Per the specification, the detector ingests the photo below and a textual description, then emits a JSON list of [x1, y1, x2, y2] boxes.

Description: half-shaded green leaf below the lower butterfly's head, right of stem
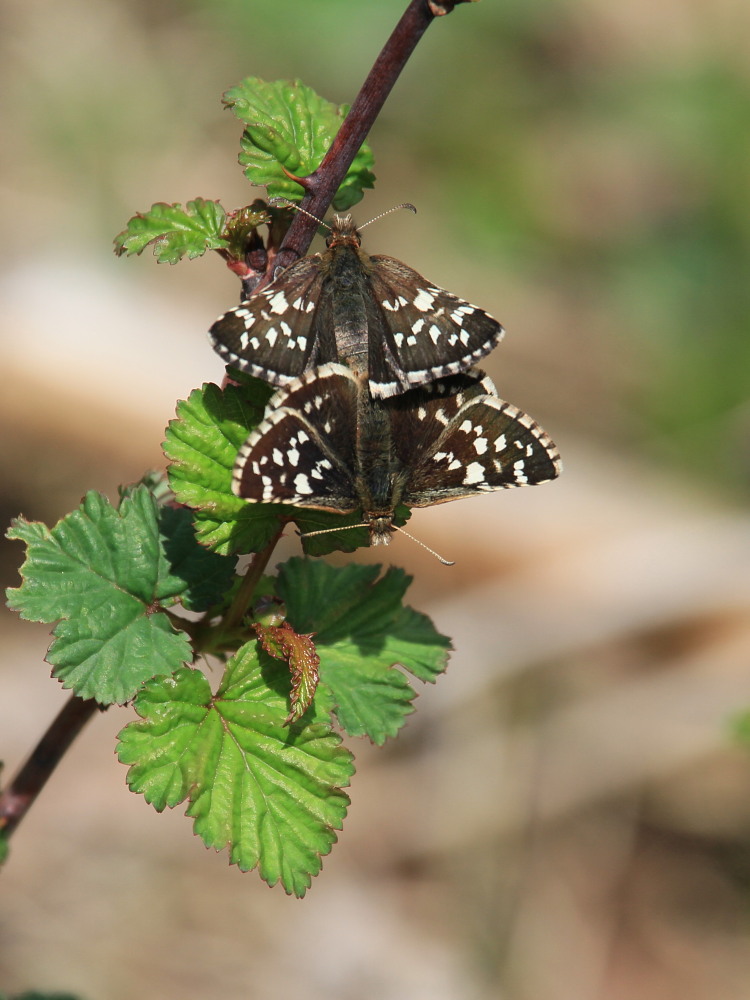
[[278, 559, 451, 745]]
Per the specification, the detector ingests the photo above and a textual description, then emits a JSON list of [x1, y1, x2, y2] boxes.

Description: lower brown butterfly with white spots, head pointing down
[[232, 363, 561, 545]]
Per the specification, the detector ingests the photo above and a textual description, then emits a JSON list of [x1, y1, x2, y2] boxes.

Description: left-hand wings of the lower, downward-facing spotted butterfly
[[232, 364, 359, 513]]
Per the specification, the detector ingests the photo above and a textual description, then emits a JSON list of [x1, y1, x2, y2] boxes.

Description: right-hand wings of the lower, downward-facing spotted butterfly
[[392, 376, 562, 507]]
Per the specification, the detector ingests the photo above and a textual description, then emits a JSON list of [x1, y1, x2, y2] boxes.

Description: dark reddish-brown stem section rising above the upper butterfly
[[274, 0, 435, 269]]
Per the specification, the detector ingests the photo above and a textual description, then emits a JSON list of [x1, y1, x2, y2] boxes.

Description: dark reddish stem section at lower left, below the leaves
[[0, 694, 99, 839]]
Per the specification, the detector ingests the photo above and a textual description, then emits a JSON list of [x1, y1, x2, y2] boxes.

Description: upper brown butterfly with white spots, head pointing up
[[209, 212, 504, 399]]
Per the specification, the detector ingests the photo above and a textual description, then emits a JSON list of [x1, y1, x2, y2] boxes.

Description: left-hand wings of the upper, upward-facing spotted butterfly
[[208, 255, 336, 386]]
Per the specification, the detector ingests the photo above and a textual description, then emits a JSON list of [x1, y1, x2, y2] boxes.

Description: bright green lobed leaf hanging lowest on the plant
[[117, 642, 354, 896]]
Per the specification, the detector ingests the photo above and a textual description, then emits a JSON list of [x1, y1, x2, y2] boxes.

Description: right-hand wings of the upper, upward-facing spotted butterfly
[[367, 254, 504, 398]]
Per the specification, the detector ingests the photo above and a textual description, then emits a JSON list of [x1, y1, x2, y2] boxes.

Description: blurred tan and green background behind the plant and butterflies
[[0, 0, 750, 1000]]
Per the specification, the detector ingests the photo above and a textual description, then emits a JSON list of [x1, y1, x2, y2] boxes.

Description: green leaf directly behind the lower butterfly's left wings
[[164, 372, 388, 555]]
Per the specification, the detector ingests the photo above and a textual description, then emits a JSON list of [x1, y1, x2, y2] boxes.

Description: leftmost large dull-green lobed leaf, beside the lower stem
[[6, 486, 195, 704]]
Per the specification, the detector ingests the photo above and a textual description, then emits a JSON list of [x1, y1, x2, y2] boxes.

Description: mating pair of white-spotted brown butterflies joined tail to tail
[[210, 216, 560, 556]]
